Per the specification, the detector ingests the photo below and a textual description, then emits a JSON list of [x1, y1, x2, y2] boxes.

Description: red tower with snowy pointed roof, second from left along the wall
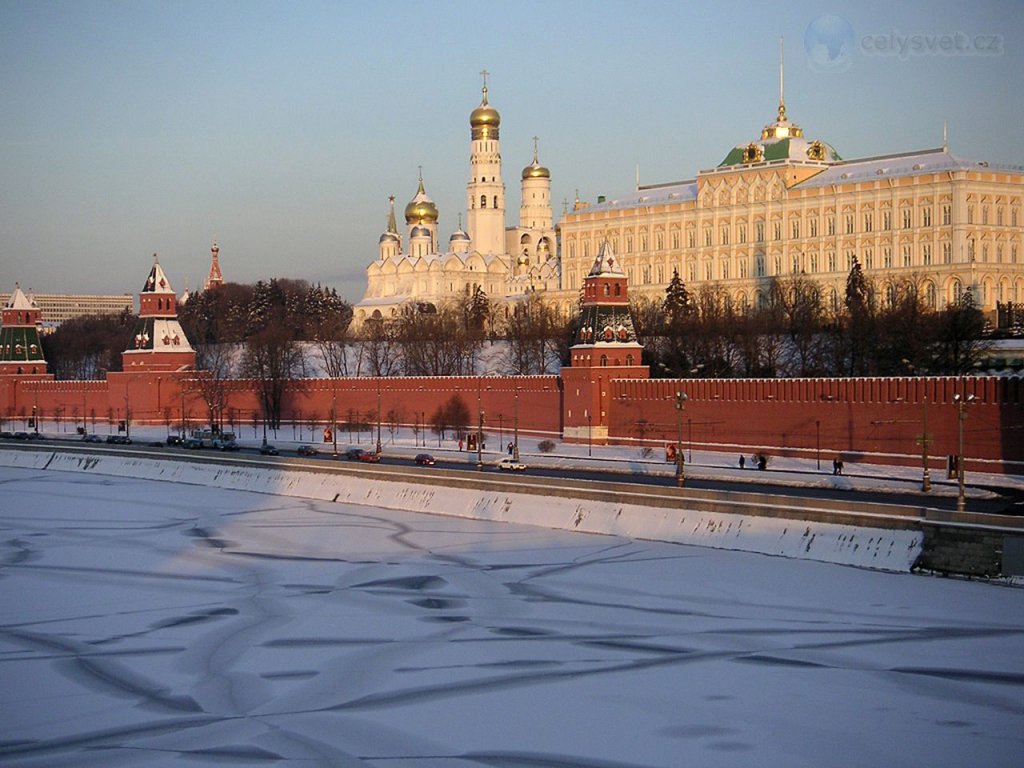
[[121, 256, 195, 373]]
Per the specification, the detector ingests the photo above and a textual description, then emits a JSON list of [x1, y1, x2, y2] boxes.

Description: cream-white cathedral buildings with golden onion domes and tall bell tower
[[354, 77, 560, 326]]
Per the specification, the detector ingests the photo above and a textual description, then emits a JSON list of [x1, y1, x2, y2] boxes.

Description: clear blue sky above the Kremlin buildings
[[0, 0, 1024, 301]]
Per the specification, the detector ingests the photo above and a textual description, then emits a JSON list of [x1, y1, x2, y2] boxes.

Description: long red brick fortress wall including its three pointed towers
[[0, 245, 1024, 474]]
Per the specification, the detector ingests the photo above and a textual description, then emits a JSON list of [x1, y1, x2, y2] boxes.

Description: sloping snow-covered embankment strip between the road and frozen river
[[0, 451, 923, 571]]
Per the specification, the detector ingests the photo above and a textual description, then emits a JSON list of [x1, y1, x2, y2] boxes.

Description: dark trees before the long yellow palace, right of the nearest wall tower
[[633, 260, 987, 377]]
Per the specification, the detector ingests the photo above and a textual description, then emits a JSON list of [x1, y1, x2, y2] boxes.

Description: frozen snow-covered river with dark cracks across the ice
[[0, 468, 1024, 768]]
